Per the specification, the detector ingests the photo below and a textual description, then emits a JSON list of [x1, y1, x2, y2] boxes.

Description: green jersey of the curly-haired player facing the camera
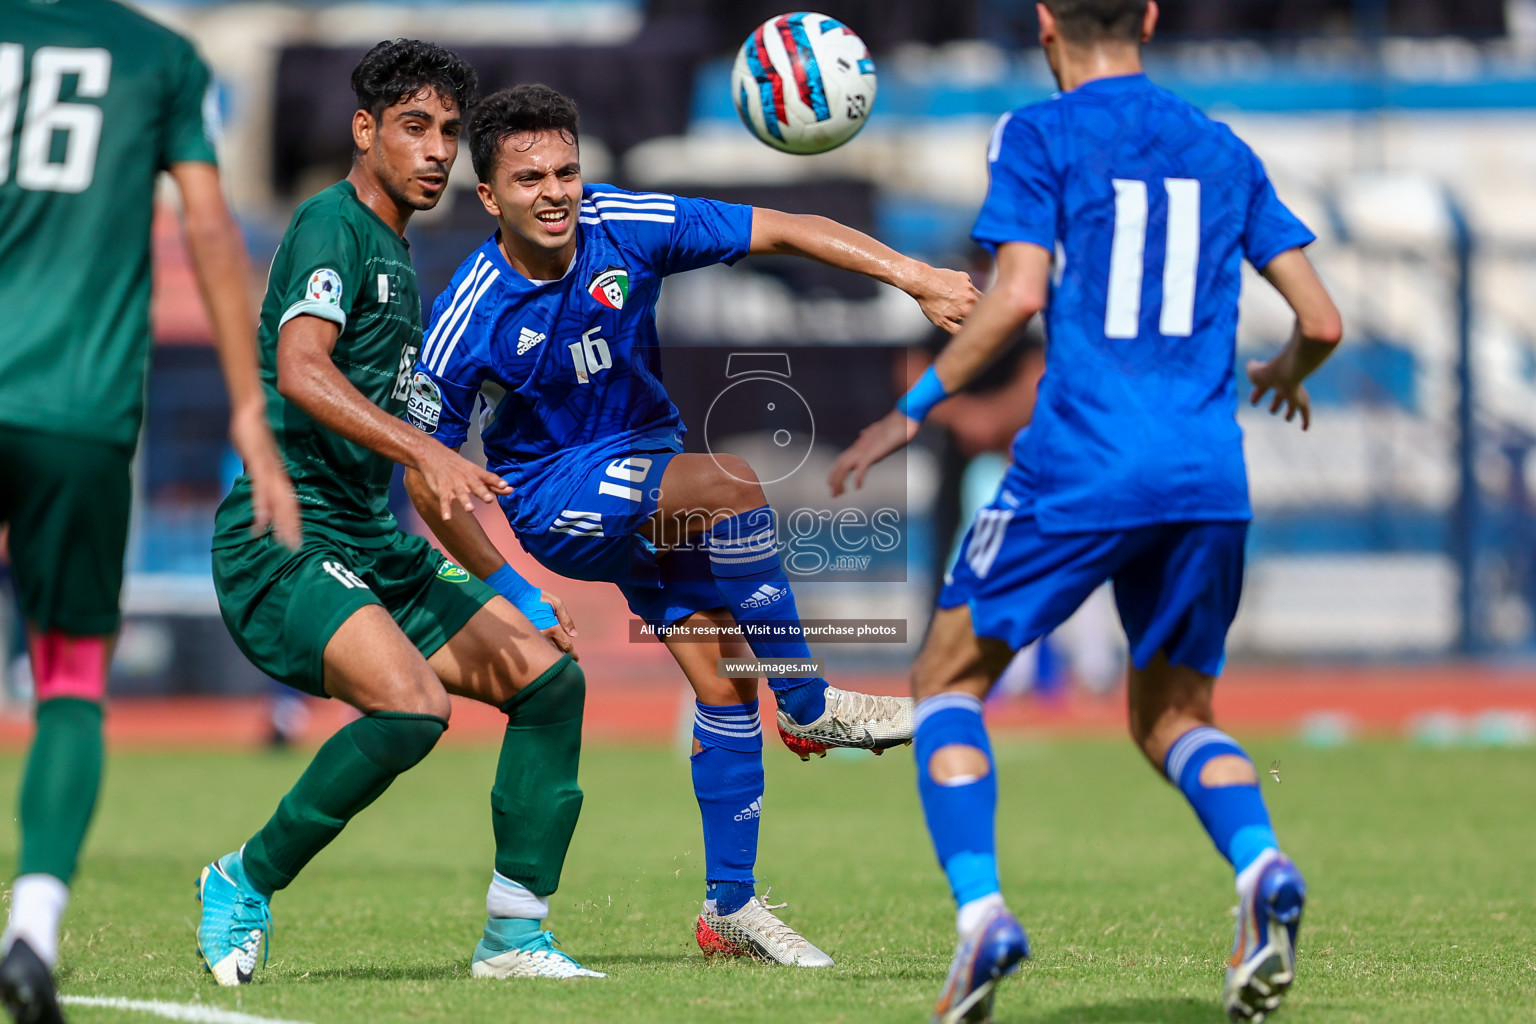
[[214, 181, 421, 548]]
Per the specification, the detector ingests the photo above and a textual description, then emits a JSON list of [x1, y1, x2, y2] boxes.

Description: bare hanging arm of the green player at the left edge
[[170, 161, 301, 548]]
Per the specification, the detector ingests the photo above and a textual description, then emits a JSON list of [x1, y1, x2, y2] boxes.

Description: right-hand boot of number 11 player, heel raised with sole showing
[[1221, 851, 1307, 1024]]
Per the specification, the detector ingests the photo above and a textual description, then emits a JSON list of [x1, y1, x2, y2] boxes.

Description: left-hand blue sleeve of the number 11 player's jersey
[[971, 111, 1061, 253]]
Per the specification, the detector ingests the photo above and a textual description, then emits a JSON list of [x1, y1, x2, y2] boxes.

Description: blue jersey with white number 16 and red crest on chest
[[407, 184, 753, 528]]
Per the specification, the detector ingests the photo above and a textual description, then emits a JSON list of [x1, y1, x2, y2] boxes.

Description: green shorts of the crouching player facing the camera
[[214, 524, 496, 697]]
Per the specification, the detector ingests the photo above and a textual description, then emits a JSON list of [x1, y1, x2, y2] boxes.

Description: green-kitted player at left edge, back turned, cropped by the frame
[[0, 0, 300, 1021]]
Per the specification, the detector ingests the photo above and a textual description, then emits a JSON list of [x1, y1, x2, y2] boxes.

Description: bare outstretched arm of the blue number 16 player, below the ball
[[748, 207, 982, 335]]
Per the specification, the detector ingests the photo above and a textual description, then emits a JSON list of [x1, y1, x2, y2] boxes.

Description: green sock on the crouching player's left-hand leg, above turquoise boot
[[243, 711, 449, 897]]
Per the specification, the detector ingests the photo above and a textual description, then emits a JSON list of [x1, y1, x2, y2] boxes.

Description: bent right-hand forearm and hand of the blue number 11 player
[[1247, 249, 1344, 430]]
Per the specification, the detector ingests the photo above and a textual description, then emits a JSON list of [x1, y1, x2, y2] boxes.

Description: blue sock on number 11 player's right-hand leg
[[1163, 725, 1279, 872]]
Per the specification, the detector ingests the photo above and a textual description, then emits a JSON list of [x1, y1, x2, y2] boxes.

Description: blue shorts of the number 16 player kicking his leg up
[[503, 451, 725, 626]]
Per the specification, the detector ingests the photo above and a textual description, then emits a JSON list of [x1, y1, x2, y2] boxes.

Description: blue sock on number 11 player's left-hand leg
[[915, 692, 1001, 906]]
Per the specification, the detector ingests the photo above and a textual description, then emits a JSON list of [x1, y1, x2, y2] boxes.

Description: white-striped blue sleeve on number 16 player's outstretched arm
[[588, 192, 753, 275]]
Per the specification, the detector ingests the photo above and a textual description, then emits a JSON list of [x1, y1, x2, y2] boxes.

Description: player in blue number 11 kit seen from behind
[[831, 0, 1342, 1024]]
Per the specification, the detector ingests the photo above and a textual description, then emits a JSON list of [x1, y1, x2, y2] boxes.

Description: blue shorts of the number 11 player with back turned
[[938, 467, 1247, 676]]
